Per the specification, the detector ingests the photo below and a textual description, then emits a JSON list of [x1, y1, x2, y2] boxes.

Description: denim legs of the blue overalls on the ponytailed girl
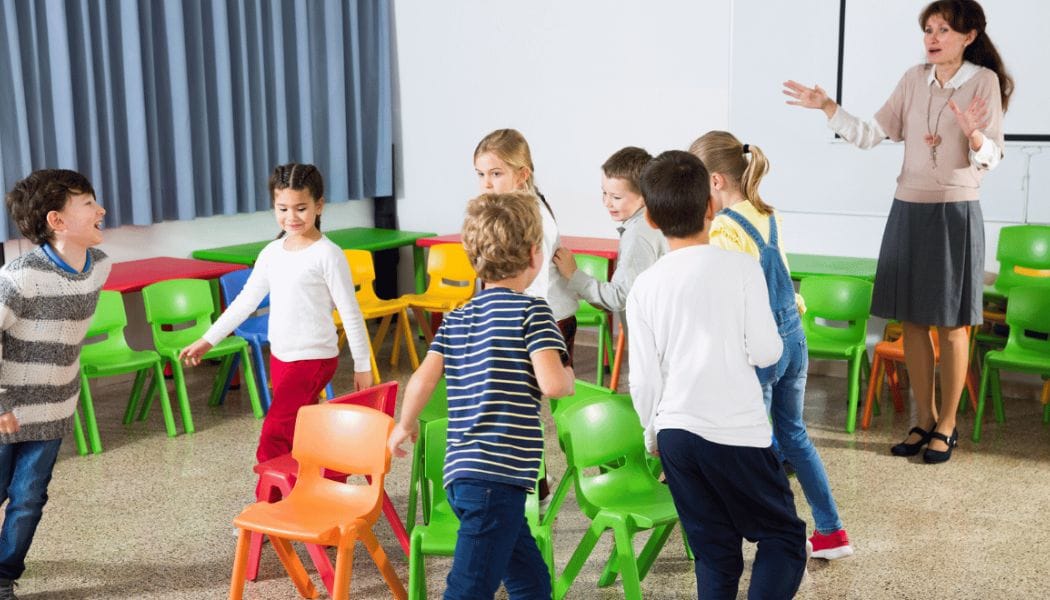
[[762, 329, 842, 535]]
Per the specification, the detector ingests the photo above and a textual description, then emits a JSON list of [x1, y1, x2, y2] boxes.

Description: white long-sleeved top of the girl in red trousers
[[204, 235, 372, 372]]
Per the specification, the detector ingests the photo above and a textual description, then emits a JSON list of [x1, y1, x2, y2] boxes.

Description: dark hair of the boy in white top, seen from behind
[[642, 150, 711, 237]]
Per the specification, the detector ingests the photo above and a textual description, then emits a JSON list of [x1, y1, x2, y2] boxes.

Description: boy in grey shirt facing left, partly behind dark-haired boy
[[554, 146, 668, 323]]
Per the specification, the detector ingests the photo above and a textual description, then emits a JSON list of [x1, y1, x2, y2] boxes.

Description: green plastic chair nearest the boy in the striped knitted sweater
[[75, 291, 175, 456]]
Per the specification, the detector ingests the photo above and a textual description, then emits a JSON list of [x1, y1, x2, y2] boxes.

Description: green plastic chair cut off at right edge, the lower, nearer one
[[973, 286, 1050, 441]]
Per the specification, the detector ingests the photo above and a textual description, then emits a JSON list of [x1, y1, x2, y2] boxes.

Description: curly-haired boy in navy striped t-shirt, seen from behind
[[390, 192, 574, 600]]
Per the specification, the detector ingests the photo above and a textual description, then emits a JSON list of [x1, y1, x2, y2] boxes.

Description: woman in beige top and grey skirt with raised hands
[[783, 0, 1013, 462]]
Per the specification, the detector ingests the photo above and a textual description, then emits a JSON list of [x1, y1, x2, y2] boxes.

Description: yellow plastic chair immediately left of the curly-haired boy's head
[[400, 244, 478, 344]]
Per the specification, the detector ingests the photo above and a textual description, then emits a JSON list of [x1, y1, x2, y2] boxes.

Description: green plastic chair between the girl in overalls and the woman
[[799, 276, 873, 433]]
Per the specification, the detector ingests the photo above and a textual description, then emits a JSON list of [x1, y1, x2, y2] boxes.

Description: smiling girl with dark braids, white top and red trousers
[[179, 163, 372, 462]]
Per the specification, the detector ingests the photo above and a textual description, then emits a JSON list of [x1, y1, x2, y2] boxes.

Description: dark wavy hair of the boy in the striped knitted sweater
[[4, 169, 95, 244]]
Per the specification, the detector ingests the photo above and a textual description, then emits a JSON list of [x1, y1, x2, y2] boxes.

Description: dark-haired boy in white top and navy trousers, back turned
[[627, 150, 805, 598]]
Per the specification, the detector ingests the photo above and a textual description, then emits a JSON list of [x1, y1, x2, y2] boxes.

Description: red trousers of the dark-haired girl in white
[[255, 355, 339, 462]]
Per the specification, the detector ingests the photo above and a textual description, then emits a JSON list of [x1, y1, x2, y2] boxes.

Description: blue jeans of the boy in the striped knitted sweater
[[0, 438, 62, 579]]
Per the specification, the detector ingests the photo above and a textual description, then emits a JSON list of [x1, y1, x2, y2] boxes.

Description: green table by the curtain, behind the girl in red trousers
[[192, 227, 437, 293]]
